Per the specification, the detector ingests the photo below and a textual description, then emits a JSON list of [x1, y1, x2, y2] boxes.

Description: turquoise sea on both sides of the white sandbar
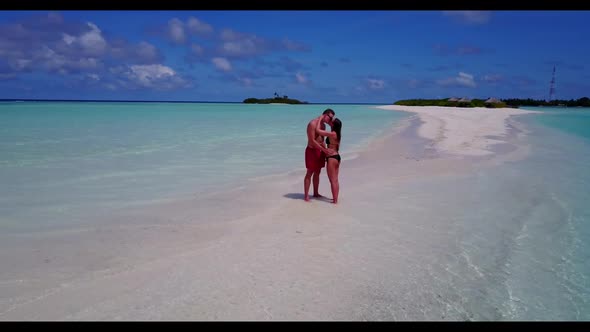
[[0, 102, 590, 320]]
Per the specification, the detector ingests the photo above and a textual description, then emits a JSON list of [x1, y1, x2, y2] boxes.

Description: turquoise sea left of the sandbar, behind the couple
[[0, 102, 408, 230]]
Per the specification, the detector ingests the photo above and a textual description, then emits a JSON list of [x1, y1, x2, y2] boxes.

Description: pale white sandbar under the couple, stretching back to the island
[[0, 105, 589, 321]]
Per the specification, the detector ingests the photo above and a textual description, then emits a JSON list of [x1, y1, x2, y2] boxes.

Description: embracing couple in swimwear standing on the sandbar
[[303, 108, 342, 204]]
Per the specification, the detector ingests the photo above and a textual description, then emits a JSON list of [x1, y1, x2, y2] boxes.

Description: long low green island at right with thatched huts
[[393, 97, 590, 108]]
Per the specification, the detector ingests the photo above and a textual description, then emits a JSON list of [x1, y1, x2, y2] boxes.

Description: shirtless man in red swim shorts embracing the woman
[[303, 108, 336, 202]]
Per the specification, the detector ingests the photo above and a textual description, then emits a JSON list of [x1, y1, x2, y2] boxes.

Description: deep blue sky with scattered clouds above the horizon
[[0, 11, 590, 103]]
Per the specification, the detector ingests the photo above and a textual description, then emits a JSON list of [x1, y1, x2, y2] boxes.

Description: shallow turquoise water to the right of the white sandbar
[[432, 107, 590, 321]]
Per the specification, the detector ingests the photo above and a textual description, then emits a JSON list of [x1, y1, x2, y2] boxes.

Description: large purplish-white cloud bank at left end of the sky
[[0, 13, 166, 86]]
